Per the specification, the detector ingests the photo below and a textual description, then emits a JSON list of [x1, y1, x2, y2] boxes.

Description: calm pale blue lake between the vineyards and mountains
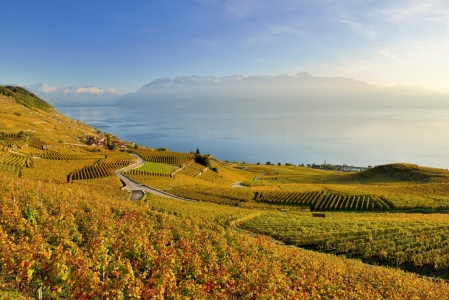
[[57, 107, 449, 168]]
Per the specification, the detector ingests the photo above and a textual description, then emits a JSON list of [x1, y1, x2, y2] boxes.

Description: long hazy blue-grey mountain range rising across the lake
[[117, 72, 449, 110]]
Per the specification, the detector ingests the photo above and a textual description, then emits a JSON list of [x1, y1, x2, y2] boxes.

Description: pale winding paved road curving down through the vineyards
[[115, 153, 197, 202]]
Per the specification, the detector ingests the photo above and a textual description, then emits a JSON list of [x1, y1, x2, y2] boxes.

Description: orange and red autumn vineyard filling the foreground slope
[[0, 176, 449, 299]]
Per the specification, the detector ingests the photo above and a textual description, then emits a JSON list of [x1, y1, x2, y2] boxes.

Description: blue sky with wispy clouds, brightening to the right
[[0, 0, 449, 93]]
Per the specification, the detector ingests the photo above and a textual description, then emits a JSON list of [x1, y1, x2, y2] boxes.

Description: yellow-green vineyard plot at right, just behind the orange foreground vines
[[241, 213, 449, 275]]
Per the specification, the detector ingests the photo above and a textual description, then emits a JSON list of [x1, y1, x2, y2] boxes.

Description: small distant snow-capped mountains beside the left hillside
[[24, 83, 122, 106]]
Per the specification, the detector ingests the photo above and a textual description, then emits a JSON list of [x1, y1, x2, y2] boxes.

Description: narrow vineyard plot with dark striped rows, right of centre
[[255, 191, 390, 211]]
